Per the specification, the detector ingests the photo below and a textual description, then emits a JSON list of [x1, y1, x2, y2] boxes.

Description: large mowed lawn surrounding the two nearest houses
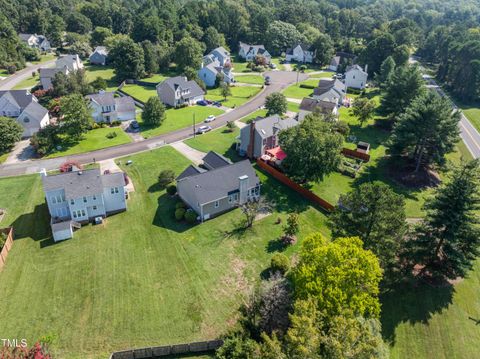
[[0, 147, 328, 359]]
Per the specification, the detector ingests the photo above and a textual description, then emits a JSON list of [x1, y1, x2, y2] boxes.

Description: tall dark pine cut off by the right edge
[[407, 159, 480, 279]]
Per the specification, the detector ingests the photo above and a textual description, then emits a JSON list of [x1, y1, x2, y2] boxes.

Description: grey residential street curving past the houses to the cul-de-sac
[[0, 71, 308, 177]]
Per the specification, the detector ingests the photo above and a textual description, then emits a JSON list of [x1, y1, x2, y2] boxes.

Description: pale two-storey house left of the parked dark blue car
[[85, 91, 135, 123]]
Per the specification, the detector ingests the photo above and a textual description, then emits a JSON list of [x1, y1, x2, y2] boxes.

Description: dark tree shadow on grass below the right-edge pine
[[380, 282, 455, 344]]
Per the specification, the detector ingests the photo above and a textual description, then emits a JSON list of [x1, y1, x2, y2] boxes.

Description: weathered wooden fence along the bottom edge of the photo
[[110, 340, 223, 359]]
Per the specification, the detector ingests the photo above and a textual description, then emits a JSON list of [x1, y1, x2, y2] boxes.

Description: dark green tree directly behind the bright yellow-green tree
[[330, 182, 406, 270]]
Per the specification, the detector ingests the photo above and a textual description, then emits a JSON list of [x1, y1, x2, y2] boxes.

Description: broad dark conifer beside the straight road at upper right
[[387, 91, 460, 172]]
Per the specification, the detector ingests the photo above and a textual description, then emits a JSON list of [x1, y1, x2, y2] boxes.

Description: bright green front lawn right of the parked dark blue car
[[138, 106, 223, 138]]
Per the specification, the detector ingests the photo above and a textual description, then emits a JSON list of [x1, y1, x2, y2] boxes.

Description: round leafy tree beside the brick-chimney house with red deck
[[279, 115, 343, 182]]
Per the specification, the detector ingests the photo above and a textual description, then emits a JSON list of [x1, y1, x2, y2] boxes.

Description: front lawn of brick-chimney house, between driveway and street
[[184, 127, 241, 162]]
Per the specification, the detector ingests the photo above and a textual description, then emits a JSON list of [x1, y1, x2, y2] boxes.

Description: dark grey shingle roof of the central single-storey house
[[179, 160, 260, 204]]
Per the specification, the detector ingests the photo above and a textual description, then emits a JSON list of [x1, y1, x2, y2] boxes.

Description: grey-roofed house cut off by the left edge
[[0, 90, 50, 137]]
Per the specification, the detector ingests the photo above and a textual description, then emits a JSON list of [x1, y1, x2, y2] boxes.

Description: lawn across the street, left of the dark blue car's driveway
[[47, 127, 131, 158]]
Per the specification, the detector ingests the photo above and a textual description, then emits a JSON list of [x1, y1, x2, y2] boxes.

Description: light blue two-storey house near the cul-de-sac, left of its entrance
[[198, 47, 235, 87]]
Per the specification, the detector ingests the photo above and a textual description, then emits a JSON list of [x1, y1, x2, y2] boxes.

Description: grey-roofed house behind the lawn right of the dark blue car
[[157, 76, 205, 107]]
